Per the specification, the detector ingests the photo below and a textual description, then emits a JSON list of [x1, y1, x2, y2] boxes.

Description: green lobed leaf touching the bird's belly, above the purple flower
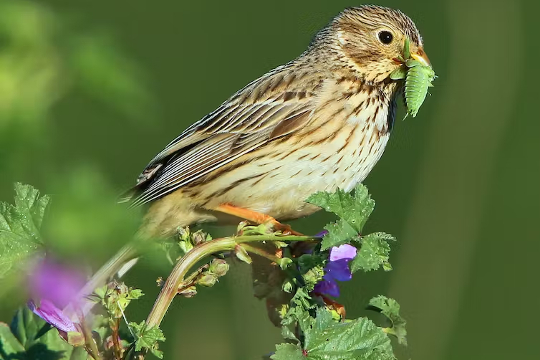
[[307, 184, 375, 250]]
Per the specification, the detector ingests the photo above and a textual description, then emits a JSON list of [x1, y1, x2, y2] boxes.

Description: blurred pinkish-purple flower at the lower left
[[28, 258, 85, 332]]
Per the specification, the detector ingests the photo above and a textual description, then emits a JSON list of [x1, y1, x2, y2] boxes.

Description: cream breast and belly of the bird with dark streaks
[[194, 88, 389, 219]]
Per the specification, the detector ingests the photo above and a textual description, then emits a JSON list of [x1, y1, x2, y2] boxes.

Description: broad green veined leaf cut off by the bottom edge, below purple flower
[[300, 309, 395, 360]]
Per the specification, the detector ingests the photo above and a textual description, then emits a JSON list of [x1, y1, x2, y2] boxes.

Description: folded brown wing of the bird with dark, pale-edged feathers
[[124, 65, 321, 206]]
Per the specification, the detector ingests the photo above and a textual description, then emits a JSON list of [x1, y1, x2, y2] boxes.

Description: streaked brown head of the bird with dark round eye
[[328, 5, 430, 84]]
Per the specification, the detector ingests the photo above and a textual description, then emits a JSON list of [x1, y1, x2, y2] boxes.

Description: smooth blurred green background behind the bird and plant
[[0, 0, 540, 360]]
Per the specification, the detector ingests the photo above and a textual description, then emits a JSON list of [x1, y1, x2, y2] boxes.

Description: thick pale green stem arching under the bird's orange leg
[[146, 234, 314, 327]]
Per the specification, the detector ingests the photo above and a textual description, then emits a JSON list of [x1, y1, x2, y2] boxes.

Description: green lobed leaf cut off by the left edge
[[0, 183, 49, 278]]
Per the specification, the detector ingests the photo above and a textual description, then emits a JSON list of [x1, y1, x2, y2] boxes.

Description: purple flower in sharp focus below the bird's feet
[[313, 244, 356, 297]]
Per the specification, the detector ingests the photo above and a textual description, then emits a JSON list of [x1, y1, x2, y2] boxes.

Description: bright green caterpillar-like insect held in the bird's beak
[[390, 39, 436, 117]]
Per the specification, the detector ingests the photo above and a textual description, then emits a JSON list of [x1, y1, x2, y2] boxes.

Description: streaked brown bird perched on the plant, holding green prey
[[82, 5, 431, 294]]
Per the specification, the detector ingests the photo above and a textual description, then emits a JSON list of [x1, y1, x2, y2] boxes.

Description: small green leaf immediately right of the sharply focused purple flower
[[351, 232, 396, 273]]
